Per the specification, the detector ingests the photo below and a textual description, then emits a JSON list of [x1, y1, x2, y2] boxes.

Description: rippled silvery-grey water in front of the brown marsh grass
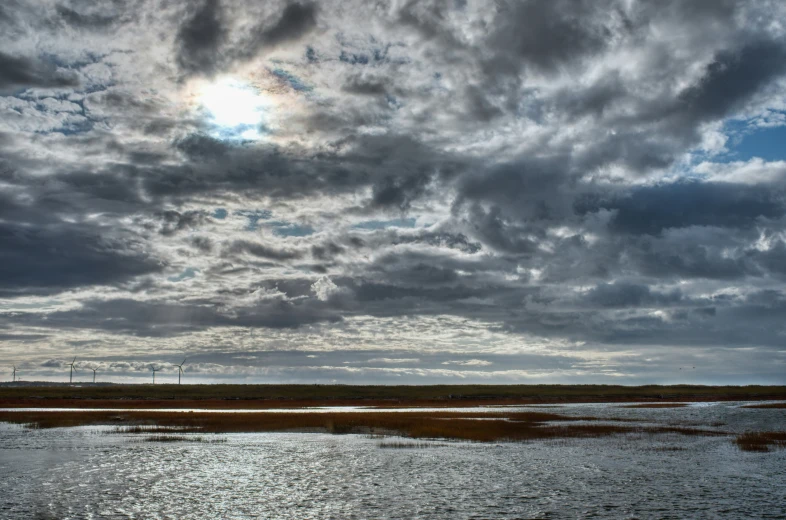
[[0, 403, 786, 519]]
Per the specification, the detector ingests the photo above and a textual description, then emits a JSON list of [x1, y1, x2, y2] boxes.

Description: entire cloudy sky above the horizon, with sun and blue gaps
[[0, 0, 786, 384]]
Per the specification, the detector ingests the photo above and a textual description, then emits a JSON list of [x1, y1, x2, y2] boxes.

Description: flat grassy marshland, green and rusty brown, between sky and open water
[[0, 383, 786, 451]]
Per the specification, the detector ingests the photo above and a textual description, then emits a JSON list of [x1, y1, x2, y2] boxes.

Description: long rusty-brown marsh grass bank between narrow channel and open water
[[0, 411, 719, 442]]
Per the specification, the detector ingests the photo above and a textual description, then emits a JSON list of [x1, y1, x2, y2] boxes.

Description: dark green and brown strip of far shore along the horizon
[[0, 383, 786, 410]]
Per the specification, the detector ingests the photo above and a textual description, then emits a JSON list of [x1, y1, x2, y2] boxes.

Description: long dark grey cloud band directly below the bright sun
[[131, 134, 460, 208]]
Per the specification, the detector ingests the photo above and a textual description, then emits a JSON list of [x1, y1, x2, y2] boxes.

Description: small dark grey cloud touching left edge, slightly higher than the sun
[[0, 51, 79, 92]]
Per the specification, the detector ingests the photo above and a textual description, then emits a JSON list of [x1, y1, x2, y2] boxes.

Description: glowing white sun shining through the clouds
[[197, 79, 270, 139]]
